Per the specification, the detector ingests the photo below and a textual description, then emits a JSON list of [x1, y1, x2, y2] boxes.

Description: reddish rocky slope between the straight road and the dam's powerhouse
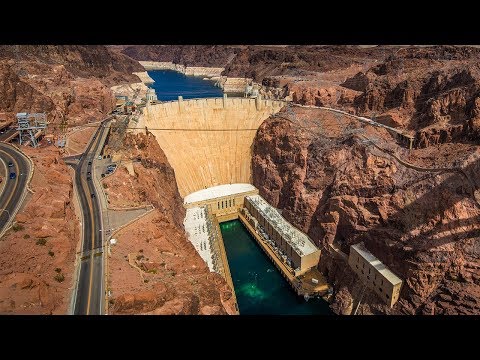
[[104, 133, 233, 315]]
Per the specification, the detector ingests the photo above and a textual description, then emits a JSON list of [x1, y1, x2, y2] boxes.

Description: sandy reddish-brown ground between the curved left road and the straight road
[[0, 146, 80, 314]]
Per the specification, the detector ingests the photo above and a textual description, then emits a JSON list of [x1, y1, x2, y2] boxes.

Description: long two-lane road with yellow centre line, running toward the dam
[[73, 120, 108, 315]]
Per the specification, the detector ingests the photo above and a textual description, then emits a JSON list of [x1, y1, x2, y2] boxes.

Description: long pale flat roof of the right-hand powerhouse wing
[[246, 195, 318, 256]]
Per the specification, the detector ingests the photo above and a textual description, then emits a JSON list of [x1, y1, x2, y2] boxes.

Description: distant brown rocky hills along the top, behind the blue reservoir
[[122, 45, 393, 82]]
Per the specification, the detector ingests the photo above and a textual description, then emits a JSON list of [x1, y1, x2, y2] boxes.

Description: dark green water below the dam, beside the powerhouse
[[220, 220, 332, 315]]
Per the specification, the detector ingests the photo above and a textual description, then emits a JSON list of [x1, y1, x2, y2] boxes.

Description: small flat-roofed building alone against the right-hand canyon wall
[[348, 242, 402, 307]]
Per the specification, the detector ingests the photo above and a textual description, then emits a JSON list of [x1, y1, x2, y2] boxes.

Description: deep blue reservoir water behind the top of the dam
[[148, 70, 223, 101]]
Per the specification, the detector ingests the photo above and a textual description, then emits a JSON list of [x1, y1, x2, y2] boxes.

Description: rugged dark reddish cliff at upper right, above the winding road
[[342, 46, 480, 147]]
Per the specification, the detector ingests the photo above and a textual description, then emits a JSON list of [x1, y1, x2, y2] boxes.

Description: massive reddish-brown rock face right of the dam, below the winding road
[[252, 108, 480, 314]]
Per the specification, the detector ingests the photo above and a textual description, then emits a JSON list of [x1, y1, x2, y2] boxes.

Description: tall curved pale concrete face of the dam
[[142, 98, 284, 197]]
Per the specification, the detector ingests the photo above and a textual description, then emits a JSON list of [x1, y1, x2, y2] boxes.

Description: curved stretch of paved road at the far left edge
[[0, 143, 32, 234]]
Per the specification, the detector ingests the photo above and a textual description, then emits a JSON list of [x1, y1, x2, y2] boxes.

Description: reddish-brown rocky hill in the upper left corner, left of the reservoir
[[0, 45, 143, 127]]
